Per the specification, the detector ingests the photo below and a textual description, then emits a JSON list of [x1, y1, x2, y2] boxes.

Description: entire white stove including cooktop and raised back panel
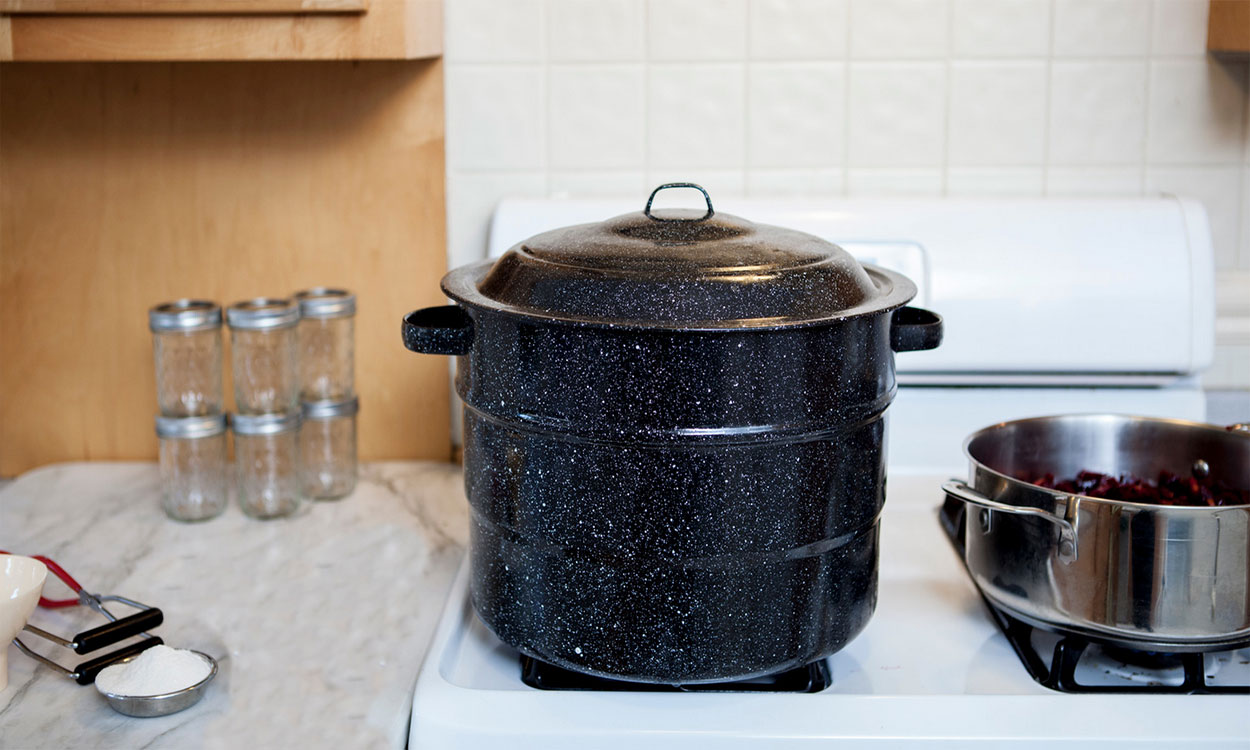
[[410, 196, 1250, 750]]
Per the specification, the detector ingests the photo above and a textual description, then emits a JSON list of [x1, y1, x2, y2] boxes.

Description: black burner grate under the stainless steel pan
[[939, 498, 1250, 695]]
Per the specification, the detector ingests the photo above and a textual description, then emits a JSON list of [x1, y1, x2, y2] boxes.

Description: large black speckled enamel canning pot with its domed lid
[[404, 185, 941, 684]]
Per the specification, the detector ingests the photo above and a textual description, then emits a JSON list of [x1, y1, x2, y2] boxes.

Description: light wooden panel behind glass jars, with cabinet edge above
[[0, 0, 450, 476]]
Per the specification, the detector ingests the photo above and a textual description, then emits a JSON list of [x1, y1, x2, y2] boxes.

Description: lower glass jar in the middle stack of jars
[[231, 411, 300, 519]]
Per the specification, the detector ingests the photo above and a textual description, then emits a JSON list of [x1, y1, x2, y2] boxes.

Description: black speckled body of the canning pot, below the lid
[[456, 308, 895, 683]]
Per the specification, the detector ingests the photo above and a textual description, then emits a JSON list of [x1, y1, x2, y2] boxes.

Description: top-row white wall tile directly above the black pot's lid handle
[[646, 0, 746, 61]]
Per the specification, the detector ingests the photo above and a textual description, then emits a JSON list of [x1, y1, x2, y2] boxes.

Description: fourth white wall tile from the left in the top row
[[749, 0, 848, 60]]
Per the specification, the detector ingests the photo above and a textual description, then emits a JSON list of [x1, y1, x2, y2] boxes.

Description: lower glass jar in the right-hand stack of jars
[[300, 398, 360, 500]]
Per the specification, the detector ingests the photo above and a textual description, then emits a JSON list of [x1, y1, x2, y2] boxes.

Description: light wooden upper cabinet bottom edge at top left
[[0, 0, 443, 61]]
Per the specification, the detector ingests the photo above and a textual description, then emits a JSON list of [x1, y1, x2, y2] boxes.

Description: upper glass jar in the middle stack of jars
[[226, 298, 300, 414]]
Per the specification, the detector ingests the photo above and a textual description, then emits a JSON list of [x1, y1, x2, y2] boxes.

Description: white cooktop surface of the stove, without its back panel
[[410, 471, 1250, 750]]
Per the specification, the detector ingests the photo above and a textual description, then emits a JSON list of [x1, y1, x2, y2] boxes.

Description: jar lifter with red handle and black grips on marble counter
[[0, 550, 165, 685]]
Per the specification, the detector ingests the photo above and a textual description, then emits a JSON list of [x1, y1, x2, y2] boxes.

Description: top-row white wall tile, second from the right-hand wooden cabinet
[[1054, 0, 1151, 58]]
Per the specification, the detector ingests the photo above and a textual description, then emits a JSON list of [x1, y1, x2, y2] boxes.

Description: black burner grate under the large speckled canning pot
[[521, 655, 834, 693]]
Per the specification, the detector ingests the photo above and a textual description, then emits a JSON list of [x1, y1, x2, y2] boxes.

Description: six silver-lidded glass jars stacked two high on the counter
[[149, 288, 360, 521]]
